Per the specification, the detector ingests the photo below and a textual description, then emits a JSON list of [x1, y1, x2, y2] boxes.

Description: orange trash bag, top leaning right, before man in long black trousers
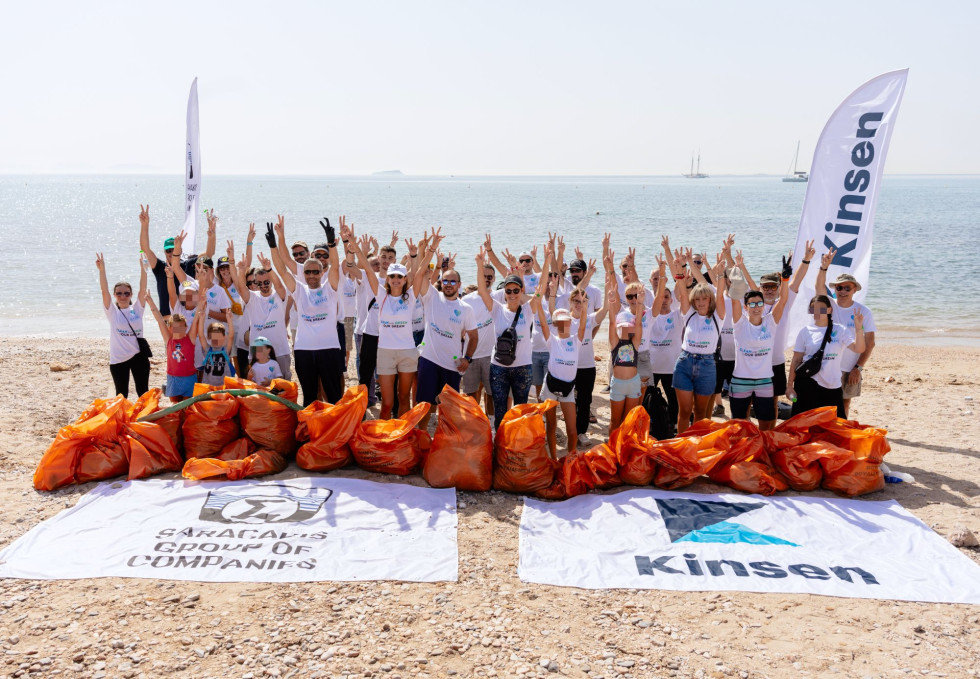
[[296, 384, 367, 472]]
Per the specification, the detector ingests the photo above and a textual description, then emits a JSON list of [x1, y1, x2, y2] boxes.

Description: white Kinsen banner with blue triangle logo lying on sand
[[518, 490, 980, 604]]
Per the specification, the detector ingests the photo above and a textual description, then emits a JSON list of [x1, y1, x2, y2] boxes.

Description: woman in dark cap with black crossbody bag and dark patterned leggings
[[476, 247, 531, 431]]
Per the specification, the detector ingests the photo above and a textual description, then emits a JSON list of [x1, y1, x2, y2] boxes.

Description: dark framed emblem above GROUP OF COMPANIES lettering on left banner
[[199, 483, 333, 524]]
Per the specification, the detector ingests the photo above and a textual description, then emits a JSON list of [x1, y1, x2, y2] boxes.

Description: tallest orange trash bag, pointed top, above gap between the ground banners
[[422, 385, 493, 491]]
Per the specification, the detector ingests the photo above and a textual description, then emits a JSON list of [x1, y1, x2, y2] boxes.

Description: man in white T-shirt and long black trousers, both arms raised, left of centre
[[270, 215, 345, 408]]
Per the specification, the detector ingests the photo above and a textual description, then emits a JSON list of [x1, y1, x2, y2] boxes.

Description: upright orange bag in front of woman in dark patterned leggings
[[493, 399, 567, 493]]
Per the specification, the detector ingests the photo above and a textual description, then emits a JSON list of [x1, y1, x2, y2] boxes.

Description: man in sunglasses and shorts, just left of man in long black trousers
[[227, 241, 293, 380]]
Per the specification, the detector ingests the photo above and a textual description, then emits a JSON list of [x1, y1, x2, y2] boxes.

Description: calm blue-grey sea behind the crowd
[[0, 176, 980, 341]]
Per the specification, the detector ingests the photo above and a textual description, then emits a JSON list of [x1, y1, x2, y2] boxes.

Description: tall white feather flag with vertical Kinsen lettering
[[788, 69, 908, 346]]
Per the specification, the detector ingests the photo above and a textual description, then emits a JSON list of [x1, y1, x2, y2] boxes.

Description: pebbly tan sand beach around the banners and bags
[[0, 338, 980, 679]]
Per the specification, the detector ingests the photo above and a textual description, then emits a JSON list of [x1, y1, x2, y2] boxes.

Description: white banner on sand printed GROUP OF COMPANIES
[[0, 477, 458, 582]]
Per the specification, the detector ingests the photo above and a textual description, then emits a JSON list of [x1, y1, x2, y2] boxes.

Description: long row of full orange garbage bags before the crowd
[[34, 378, 890, 499]]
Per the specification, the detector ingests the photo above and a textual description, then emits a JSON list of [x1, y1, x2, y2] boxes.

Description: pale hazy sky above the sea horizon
[[0, 0, 980, 175]]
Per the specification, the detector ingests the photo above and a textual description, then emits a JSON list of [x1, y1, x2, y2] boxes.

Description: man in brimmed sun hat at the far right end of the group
[[816, 248, 875, 417]]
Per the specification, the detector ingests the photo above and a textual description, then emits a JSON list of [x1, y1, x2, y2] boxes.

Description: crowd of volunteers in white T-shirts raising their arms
[[96, 206, 875, 454]]
